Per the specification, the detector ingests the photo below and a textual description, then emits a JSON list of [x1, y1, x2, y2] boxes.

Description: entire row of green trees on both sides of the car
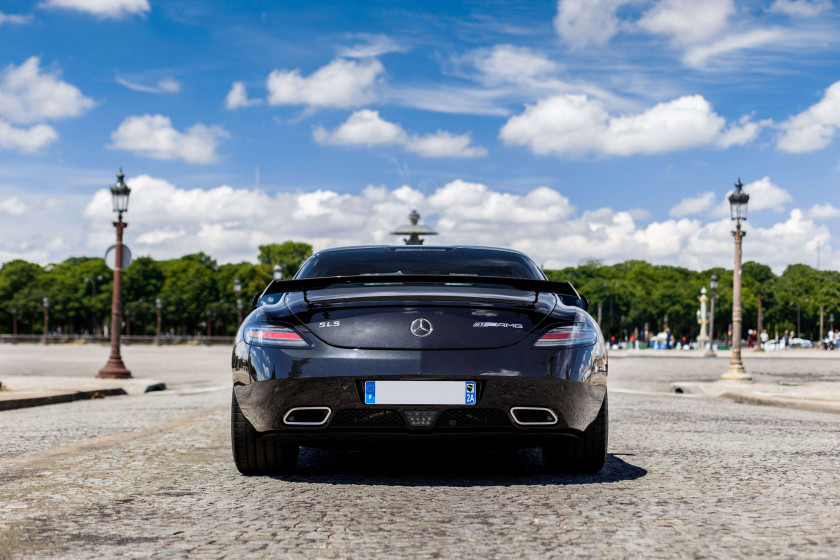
[[0, 241, 840, 340]]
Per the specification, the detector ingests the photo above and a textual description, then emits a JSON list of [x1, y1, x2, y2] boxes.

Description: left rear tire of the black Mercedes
[[230, 392, 299, 475]]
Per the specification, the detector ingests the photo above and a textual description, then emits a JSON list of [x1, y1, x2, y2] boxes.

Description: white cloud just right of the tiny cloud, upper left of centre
[[267, 58, 385, 108]]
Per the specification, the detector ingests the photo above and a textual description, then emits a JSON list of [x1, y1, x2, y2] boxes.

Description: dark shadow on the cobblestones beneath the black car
[[276, 448, 647, 486]]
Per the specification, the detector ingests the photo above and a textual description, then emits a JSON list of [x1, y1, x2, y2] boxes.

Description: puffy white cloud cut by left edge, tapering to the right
[[0, 56, 94, 124]]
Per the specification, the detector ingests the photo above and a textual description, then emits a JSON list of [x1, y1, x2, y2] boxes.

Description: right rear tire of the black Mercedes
[[542, 394, 609, 474]]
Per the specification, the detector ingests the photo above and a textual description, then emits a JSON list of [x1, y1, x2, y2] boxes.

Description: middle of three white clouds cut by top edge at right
[[638, 0, 735, 45]]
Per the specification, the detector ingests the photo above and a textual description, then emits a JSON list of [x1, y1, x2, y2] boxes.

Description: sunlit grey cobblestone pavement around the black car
[[0, 352, 840, 560]]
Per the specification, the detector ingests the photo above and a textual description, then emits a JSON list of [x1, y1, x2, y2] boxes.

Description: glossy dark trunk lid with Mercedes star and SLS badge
[[285, 285, 575, 350]]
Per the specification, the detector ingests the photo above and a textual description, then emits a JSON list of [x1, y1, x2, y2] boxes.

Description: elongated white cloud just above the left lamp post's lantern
[[108, 115, 228, 163]]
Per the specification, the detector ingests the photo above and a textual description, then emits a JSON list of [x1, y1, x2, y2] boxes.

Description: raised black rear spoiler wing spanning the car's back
[[254, 274, 589, 310]]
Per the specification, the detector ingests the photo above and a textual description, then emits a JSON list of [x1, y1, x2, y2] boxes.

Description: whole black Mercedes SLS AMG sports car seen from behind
[[231, 246, 607, 474]]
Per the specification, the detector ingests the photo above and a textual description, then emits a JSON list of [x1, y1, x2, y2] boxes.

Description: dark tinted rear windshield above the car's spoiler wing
[[296, 247, 545, 280]]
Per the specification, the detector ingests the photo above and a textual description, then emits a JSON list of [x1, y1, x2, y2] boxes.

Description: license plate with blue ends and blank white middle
[[365, 381, 476, 405]]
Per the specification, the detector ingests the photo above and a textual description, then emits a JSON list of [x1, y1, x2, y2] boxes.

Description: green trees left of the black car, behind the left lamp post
[[0, 241, 312, 336]]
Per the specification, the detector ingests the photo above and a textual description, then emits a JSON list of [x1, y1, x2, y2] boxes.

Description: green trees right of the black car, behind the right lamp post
[[546, 260, 840, 341]]
